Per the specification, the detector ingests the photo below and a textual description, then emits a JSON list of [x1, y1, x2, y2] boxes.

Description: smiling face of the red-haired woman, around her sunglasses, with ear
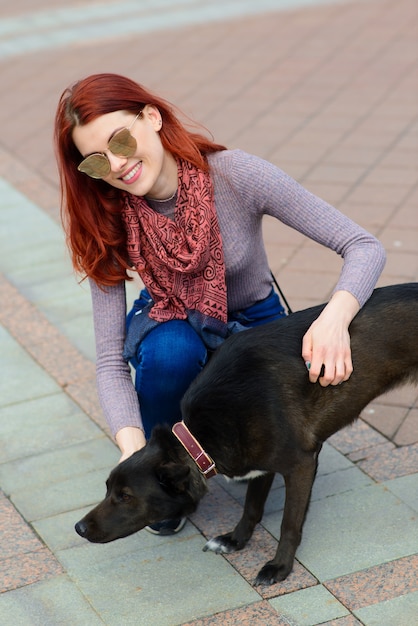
[[72, 105, 177, 199]]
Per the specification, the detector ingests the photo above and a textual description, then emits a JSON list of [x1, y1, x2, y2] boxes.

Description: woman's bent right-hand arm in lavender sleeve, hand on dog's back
[[225, 152, 386, 386]]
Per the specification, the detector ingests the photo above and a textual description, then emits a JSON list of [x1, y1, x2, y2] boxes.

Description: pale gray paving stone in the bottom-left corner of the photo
[[0, 576, 103, 626]]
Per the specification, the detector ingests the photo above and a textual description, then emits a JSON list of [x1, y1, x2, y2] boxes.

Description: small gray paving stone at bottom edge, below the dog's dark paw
[[270, 585, 349, 626]]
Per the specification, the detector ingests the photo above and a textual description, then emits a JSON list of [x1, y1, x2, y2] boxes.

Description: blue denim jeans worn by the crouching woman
[[127, 290, 285, 439]]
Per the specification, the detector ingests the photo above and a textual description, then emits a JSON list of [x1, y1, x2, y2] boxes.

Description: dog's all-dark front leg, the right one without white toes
[[255, 452, 318, 585]]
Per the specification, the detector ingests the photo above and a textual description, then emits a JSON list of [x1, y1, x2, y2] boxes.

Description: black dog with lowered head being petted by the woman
[[76, 283, 418, 584]]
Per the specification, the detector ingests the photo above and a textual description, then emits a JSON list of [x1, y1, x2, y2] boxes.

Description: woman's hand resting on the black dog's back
[[302, 291, 360, 387]]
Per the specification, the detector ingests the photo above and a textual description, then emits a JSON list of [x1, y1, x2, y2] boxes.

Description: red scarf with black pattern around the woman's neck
[[123, 161, 227, 323]]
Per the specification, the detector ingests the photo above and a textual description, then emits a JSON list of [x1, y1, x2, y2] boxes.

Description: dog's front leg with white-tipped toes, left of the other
[[203, 474, 274, 554]]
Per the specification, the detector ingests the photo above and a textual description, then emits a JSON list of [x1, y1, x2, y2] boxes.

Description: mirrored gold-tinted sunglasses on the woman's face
[[77, 111, 142, 178]]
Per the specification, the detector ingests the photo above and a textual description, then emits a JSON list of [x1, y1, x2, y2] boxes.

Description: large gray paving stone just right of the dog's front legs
[[263, 485, 418, 581]]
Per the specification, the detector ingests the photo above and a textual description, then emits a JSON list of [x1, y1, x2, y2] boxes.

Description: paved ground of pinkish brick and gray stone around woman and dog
[[0, 0, 418, 626]]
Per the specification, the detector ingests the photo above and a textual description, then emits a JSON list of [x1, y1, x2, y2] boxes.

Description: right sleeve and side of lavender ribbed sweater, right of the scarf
[[210, 150, 386, 309]]
